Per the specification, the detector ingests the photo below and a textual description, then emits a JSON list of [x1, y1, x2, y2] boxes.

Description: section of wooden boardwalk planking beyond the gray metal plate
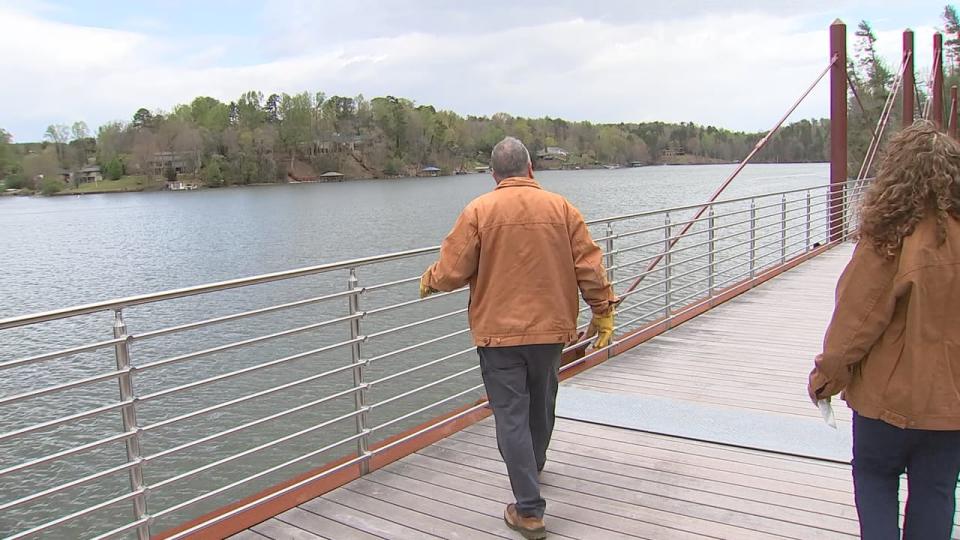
[[565, 246, 852, 422]]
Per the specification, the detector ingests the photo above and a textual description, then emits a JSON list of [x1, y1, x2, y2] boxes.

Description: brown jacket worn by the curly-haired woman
[[810, 217, 960, 430]]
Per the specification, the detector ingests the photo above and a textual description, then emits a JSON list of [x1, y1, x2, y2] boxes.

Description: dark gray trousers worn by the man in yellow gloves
[[477, 343, 563, 518]]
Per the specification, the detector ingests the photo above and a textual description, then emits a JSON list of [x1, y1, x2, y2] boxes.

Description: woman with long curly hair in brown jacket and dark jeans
[[808, 121, 960, 540]]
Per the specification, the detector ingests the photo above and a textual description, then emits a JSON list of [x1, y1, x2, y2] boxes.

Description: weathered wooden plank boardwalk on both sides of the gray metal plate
[[225, 246, 952, 540]]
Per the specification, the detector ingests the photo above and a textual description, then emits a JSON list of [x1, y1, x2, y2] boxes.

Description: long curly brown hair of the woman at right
[[860, 120, 960, 258]]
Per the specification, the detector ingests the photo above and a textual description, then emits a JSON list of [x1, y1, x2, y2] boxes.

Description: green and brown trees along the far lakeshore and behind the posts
[[0, 5, 960, 189]]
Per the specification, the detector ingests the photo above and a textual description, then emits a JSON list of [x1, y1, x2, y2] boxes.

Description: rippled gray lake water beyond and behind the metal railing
[[0, 164, 829, 537]]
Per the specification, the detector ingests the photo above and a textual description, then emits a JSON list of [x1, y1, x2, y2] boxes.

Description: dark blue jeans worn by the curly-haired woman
[[853, 413, 960, 540]]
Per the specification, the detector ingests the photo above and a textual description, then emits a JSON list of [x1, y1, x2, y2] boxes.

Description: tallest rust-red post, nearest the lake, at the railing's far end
[[827, 19, 847, 241]]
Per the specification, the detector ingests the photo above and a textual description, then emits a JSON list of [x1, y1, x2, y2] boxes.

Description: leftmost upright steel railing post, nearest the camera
[[113, 309, 150, 540]]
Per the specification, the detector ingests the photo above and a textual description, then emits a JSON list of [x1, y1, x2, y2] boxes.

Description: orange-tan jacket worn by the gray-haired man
[[423, 177, 614, 347]]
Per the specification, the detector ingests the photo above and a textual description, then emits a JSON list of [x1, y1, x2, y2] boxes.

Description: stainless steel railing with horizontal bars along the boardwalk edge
[[0, 179, 859, 538]]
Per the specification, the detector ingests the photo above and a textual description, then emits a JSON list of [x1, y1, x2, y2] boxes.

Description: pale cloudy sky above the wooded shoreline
[[0, 0, 944, 141]]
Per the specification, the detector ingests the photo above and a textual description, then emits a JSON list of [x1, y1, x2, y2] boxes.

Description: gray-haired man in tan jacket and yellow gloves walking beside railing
[[420, 137, 617, 538]]
